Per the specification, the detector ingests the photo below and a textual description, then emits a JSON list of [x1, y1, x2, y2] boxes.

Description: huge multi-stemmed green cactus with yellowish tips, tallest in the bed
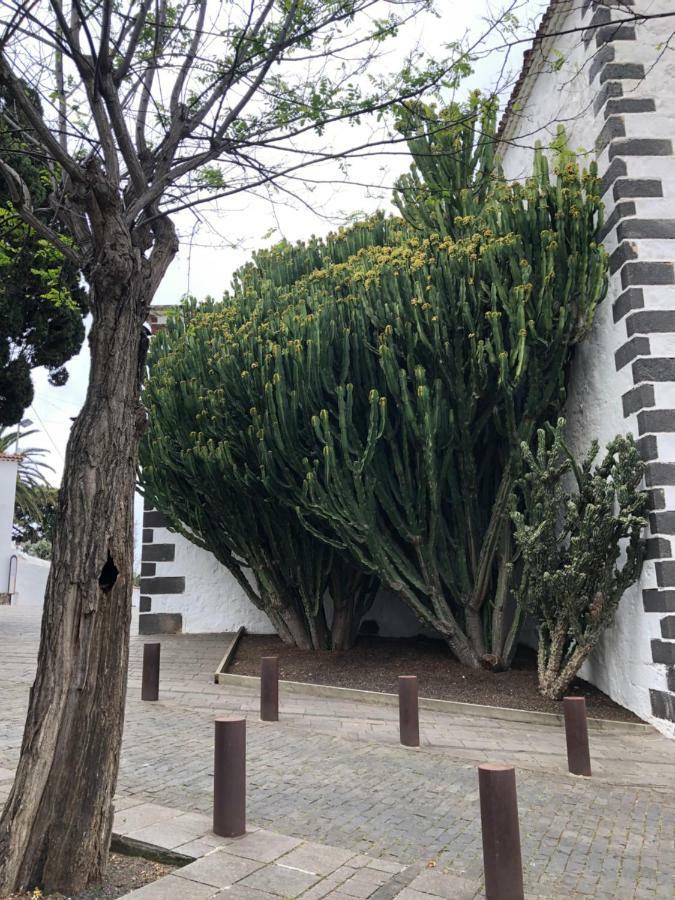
[[145, 96, 606, 667]]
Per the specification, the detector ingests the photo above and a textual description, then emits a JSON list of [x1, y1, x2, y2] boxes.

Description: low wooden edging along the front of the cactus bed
[[215, 672, 654, 733]]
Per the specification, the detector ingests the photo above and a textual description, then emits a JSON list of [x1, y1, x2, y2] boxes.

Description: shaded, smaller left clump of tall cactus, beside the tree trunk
[[140, 305, 375, 649]]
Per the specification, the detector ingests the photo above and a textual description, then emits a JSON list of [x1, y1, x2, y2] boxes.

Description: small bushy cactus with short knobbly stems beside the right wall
[[511, 419, 648, 700]]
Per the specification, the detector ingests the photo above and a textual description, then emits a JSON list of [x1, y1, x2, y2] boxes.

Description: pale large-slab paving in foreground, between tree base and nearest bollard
[[114, 799, 438, 900]]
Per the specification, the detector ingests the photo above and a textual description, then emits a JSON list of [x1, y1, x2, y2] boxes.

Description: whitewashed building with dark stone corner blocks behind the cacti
[[140, 0, 675, 737]]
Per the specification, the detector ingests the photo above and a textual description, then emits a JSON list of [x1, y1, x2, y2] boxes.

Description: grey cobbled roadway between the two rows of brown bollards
[[0, 607, 675, 900]]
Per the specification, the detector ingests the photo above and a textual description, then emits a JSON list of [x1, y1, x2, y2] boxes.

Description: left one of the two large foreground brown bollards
[[213, 719, 246, 837]]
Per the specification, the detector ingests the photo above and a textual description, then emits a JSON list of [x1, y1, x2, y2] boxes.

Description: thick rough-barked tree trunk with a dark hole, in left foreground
[[0, 198, 177, 895]]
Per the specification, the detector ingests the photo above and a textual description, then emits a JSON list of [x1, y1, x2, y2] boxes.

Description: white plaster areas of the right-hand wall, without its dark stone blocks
[[503, 0, 675, 736]]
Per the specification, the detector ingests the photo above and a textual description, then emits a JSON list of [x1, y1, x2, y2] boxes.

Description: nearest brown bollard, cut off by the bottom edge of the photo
[[478, 763, 525, 900]]
